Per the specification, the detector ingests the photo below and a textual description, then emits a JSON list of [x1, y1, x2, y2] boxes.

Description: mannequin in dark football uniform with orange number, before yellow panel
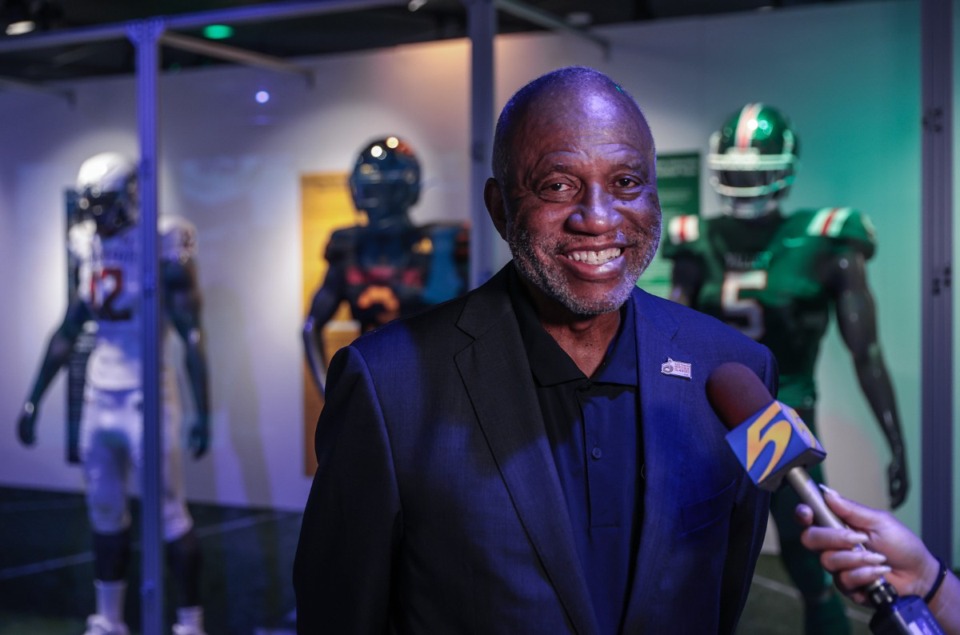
[[303, 137, 469, 394]]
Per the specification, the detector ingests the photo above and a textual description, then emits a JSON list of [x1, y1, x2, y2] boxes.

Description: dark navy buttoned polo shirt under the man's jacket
[[510, 276, 643, 635]]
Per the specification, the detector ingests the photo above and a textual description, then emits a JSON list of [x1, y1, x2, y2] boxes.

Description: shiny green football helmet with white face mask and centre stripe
[[707, 103, 799, 218]]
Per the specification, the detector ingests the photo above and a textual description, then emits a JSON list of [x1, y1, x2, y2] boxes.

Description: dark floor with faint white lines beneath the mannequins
[[0, 487, 870, 635]]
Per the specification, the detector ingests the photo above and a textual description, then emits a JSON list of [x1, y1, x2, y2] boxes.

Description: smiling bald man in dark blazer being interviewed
[[294, 67, 777, 635]]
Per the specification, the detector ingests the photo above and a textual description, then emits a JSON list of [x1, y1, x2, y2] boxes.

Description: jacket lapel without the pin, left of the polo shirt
[[456, 268, 598, 634]]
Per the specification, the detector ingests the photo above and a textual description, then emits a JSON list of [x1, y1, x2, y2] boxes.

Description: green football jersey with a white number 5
[[663, 207, 876, 408]]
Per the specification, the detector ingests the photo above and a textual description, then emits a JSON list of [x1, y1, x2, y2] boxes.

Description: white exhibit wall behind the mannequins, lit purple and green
[[0, 1, 920, 526]]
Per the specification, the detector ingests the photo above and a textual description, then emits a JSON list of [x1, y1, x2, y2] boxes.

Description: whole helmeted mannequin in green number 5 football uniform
[[662, 104, 908, 635]]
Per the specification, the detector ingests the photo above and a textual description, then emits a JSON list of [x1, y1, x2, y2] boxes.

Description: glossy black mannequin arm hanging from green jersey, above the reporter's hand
[[833, 254, 909, 508]]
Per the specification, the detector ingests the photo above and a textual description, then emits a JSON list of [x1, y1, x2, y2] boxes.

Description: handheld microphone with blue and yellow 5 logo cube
[[707, 362, 943, 635]]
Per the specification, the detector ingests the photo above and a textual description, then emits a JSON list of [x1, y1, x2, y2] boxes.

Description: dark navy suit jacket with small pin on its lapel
[[294, 265, 777, 635]]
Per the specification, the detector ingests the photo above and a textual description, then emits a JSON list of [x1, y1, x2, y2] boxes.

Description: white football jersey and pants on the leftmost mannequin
[[69, 216, 196, 541]]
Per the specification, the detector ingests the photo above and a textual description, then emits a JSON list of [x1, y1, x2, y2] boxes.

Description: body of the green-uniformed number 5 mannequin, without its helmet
[[663, 208, 907, 633]]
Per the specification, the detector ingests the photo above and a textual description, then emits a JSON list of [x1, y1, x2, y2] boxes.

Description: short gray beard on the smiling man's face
[[507, 223, 660, 317]]
